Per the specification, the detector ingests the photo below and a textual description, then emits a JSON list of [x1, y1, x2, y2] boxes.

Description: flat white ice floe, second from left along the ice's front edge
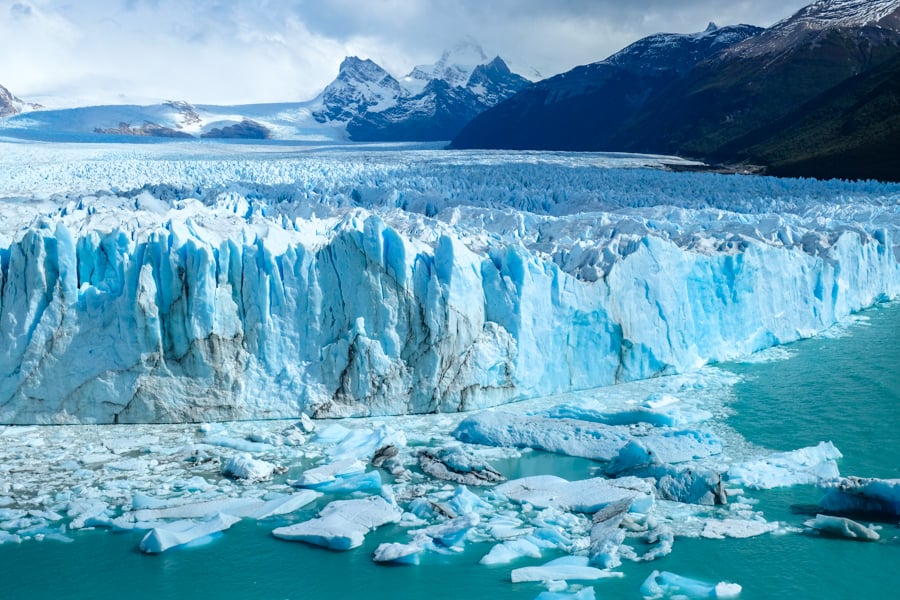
[[272, 496, 402, 550]]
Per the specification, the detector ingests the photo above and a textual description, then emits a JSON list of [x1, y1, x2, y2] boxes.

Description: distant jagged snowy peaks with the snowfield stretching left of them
[[0, 41, 530, 142]]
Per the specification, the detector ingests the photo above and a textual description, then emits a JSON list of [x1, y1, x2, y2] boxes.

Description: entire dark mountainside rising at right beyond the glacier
[[453, 0, 900, 179]]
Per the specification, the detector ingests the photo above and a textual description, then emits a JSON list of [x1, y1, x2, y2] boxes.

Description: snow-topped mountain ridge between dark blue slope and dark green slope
[[619, 0, 900, 160]]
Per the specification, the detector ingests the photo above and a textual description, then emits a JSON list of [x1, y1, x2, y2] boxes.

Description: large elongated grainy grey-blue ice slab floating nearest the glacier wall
[[453, 411, 631, 461]]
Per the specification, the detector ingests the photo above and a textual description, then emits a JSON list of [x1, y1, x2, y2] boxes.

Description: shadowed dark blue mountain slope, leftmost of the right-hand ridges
[[453, 24, 762, 150]]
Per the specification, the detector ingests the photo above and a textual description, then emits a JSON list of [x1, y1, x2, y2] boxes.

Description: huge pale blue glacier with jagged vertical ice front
[[0, 141, 900, 424]]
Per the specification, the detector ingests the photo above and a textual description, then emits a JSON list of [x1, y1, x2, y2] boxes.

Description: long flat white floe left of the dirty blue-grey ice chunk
[[495, 475, 653, 514]]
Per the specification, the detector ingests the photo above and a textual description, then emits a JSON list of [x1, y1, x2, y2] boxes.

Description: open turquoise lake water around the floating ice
[[0, 305, 900, 600]]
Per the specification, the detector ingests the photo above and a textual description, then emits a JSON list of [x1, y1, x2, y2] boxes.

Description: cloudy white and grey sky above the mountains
[[0, 0, 810, 106]]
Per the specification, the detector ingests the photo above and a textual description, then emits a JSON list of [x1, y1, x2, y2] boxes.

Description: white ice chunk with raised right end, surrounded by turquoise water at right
[[728, 442, 843, 490]]
